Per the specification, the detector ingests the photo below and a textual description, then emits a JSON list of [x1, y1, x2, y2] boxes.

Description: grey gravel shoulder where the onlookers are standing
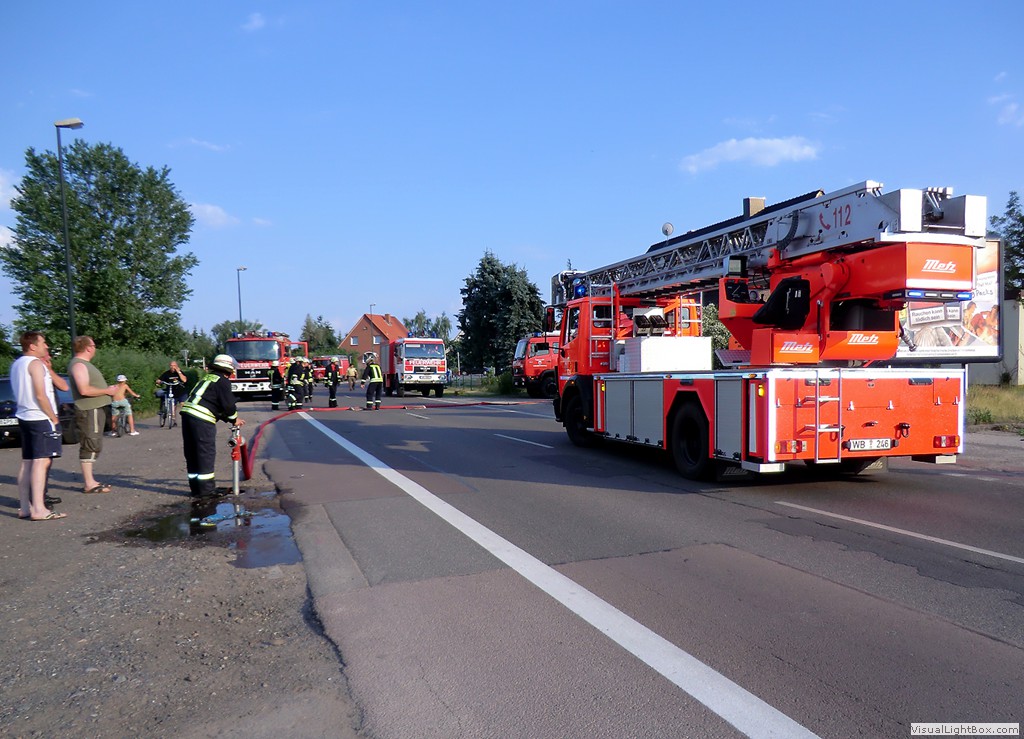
[[0, 403, 359, 737]]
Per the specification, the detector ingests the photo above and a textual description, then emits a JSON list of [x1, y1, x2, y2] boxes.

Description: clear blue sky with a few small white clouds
[[0, 0, 1024, 336]]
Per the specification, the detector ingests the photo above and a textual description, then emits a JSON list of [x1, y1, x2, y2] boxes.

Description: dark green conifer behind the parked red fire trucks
[[459, 251, 544, 371]]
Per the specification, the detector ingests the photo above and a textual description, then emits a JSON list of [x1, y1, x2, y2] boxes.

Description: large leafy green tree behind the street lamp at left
[[0, 140, 198, 350]]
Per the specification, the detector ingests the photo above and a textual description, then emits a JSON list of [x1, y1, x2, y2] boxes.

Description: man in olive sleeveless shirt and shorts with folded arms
[[68, 336, 117, 492]]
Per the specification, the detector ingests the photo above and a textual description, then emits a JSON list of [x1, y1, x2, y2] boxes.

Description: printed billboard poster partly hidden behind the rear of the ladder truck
[[896, 240, 1002, 362]]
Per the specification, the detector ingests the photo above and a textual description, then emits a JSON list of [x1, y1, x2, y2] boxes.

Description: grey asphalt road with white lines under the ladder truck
[[260, 394, 1024, 738]]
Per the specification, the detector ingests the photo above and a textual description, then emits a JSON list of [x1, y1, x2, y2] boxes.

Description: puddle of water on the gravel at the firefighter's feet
[[120, 491, 302, 569]]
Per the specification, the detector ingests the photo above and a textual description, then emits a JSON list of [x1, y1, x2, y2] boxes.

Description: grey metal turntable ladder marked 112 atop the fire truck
[[551, 180, 986, 306]]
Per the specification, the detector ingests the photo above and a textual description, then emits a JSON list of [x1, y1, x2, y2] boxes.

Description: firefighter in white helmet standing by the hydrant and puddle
[[181, 354, 246, 498]]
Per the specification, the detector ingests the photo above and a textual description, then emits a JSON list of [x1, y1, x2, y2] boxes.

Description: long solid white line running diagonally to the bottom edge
[[299, 412, 816, 739]]
